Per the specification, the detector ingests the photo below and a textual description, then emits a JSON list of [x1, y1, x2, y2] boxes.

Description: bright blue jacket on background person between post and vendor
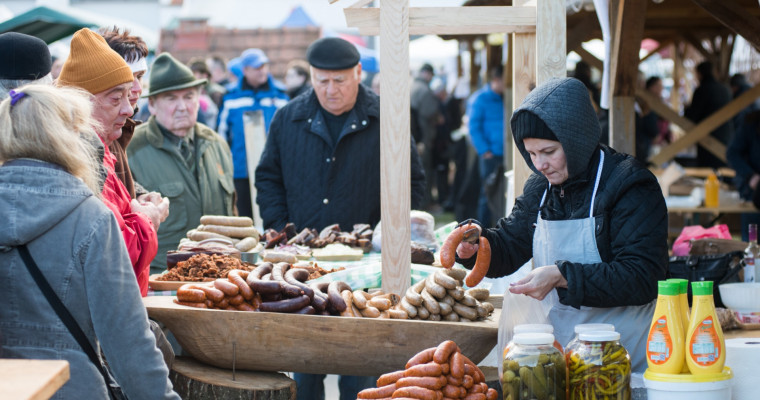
[[467, 85, 504, 156]]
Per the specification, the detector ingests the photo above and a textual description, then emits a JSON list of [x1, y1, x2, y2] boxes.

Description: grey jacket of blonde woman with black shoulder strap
[[0, 159, 179, 399]]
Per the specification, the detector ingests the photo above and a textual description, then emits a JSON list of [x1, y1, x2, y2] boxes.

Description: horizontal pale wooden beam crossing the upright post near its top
[[343, 4, 536, 37]]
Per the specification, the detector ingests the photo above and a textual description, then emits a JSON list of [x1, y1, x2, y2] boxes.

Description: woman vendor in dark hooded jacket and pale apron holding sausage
[[457, 78, 668, 372]]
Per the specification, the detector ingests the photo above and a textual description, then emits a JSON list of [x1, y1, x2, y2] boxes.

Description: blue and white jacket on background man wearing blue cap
[[217, 76, 289, 179]]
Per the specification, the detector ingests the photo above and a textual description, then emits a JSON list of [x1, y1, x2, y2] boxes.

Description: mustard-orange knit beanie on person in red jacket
[[58, 28, 133, 94]]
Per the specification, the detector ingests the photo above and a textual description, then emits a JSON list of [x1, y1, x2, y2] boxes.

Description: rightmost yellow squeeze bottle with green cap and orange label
[[686, 281, 726, 375]]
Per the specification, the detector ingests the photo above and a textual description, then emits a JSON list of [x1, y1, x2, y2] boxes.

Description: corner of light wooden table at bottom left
[[0, 359, 69, 400]]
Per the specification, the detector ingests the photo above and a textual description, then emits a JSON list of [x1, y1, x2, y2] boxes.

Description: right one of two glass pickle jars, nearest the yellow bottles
[[567, 331, 631, 400]]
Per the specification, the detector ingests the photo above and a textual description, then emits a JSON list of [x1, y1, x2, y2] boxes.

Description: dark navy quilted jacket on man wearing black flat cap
[[256, 85, 425, 231]]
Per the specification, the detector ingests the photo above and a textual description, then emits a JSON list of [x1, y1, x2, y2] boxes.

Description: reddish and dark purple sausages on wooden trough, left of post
[[175, 262, 351, 315]]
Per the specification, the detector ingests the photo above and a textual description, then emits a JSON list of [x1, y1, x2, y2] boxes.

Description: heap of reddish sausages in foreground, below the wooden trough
[[357, 340, 498, 400]]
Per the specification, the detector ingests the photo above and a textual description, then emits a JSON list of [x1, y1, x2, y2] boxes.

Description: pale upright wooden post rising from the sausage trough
[[378, 0, 412, 293]]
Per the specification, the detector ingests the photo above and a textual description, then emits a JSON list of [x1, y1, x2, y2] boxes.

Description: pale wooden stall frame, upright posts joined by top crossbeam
[[328, 0, 566, 293]]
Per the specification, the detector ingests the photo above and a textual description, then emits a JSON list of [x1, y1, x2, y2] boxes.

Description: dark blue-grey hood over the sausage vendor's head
[[510, 78, 601, 179]]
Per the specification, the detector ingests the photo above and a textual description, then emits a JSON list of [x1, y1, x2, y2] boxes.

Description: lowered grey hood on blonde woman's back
[[0, 159, 93, 249]]
